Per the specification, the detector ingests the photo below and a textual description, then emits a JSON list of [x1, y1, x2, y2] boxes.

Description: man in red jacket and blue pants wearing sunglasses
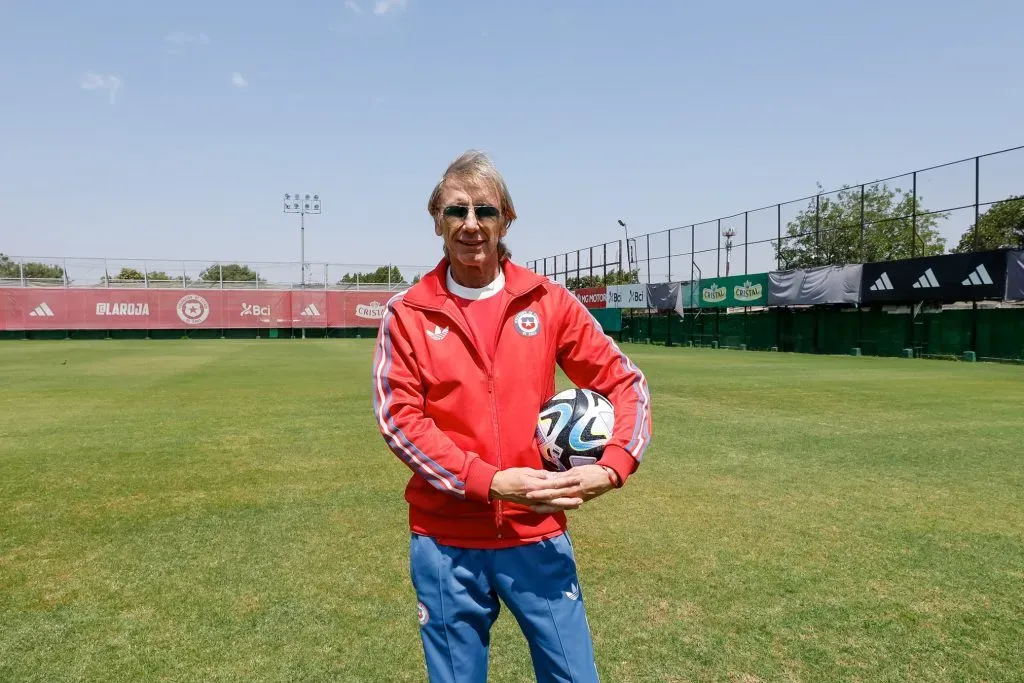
[[373, 152, 651, 683]]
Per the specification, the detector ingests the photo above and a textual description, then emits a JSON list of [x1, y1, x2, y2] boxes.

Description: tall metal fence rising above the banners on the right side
[[526, 145, 1024, 284]]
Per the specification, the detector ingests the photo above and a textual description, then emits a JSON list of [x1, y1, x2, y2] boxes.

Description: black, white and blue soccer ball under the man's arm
[[537, 389, 615, 472]]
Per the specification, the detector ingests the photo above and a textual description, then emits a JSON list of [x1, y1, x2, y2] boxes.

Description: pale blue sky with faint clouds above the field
[[0, 0, 1024, 282]]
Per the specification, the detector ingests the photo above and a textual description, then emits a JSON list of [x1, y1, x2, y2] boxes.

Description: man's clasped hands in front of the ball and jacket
[[490, 465, 613, 514]]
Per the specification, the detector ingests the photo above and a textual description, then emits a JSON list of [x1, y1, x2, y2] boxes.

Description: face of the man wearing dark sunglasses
[[435, 180, 507, 268]]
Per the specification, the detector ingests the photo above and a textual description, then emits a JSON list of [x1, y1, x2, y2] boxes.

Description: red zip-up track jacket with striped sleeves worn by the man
[[373, 259, 651, 548]]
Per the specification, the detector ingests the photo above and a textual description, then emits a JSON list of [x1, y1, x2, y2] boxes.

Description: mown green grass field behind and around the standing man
[[0, 340, 1024, 683]]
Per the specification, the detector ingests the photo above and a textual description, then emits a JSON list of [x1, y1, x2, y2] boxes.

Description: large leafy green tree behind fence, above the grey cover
[[772, 183, 946, 268]]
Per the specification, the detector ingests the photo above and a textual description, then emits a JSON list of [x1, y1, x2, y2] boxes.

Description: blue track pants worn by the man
[[410, 533, 598, 683]]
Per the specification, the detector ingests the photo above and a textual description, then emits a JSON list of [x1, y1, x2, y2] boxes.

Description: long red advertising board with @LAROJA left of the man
[[0, 288, 391, 330]]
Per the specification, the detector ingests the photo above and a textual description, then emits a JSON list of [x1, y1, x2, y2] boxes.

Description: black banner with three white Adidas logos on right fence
[[860, 251, 1007, 303]]
